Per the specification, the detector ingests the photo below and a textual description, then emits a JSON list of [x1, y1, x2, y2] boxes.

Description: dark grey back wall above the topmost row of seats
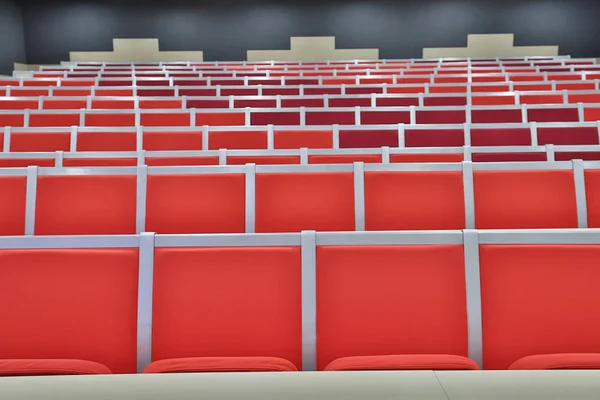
[[0, 0, 600, 73]]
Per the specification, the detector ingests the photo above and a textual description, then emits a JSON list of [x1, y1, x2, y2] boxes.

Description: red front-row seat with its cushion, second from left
[[144, 238, 302, 373]]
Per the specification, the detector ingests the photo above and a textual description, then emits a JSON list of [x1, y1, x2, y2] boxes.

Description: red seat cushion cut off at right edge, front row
[[508, 353, 600, 369]]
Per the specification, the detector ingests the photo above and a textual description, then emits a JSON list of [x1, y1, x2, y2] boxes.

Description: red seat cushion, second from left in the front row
[[144, 357, 298, 374]]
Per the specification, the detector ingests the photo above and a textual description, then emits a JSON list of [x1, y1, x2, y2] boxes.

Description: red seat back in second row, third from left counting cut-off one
[[146, 174, 246, 234]]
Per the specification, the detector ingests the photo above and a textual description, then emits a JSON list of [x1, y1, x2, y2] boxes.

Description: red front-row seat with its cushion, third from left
[[316, 236, 478, 371]]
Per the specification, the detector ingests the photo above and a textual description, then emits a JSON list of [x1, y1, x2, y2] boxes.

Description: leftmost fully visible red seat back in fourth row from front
[[10, 130, 71, 152]]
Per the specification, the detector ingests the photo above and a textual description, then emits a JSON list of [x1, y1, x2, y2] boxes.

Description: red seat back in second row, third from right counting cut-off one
[[365, 171, 465, 231]]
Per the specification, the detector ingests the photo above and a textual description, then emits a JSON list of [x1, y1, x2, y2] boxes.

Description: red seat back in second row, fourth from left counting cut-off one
[[255, 165, 355, 232]]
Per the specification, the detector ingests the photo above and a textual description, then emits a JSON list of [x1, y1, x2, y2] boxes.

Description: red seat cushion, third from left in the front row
[[325, 354, 479, 371]]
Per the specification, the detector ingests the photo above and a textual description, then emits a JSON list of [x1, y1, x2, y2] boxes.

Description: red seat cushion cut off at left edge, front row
[[0, 359, 112, 376]]
